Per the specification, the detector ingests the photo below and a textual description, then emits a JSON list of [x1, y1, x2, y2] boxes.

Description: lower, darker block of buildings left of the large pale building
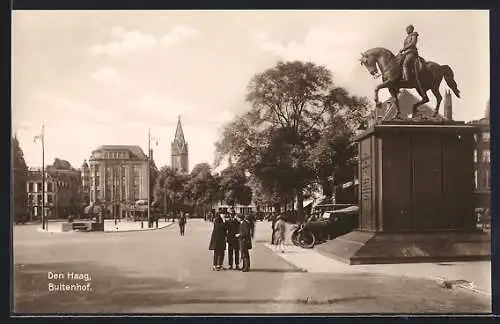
[[26, 159, 81, 220]]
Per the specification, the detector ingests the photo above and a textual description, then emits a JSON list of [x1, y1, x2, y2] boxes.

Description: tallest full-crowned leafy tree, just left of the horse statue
[[216, 61, 366, 220]]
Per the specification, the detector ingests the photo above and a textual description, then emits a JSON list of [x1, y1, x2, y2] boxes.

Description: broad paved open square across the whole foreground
[[13, 220, 491, 314]]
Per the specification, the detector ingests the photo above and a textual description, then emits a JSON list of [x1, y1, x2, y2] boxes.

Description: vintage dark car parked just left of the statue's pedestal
[[292, 206, 359, 248]]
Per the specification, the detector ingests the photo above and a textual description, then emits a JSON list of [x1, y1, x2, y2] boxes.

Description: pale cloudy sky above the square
[[12, 10, 490, 168]]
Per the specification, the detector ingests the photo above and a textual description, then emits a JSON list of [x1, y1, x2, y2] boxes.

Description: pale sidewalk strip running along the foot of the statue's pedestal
[[257, 224, 491, 297]]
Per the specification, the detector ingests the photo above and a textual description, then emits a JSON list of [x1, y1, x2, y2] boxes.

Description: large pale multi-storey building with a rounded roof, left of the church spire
[[87, 145, 149, 217]]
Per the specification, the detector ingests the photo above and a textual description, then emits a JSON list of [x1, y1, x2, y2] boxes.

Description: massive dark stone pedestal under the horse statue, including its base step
[[329, 122, 490, 263]]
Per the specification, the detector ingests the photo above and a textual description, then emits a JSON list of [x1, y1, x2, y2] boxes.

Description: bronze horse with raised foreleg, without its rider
[[360, 47, 460, 118]]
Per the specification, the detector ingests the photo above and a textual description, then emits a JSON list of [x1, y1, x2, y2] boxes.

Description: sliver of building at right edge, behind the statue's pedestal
[[469, 104, 491, 208]]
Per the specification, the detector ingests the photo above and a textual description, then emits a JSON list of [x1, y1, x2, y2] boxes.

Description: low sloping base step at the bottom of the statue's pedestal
[[315, 231, 491, 264]]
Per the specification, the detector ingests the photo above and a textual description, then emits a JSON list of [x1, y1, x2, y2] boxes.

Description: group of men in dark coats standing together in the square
[[208, 213, 255, 272]]
